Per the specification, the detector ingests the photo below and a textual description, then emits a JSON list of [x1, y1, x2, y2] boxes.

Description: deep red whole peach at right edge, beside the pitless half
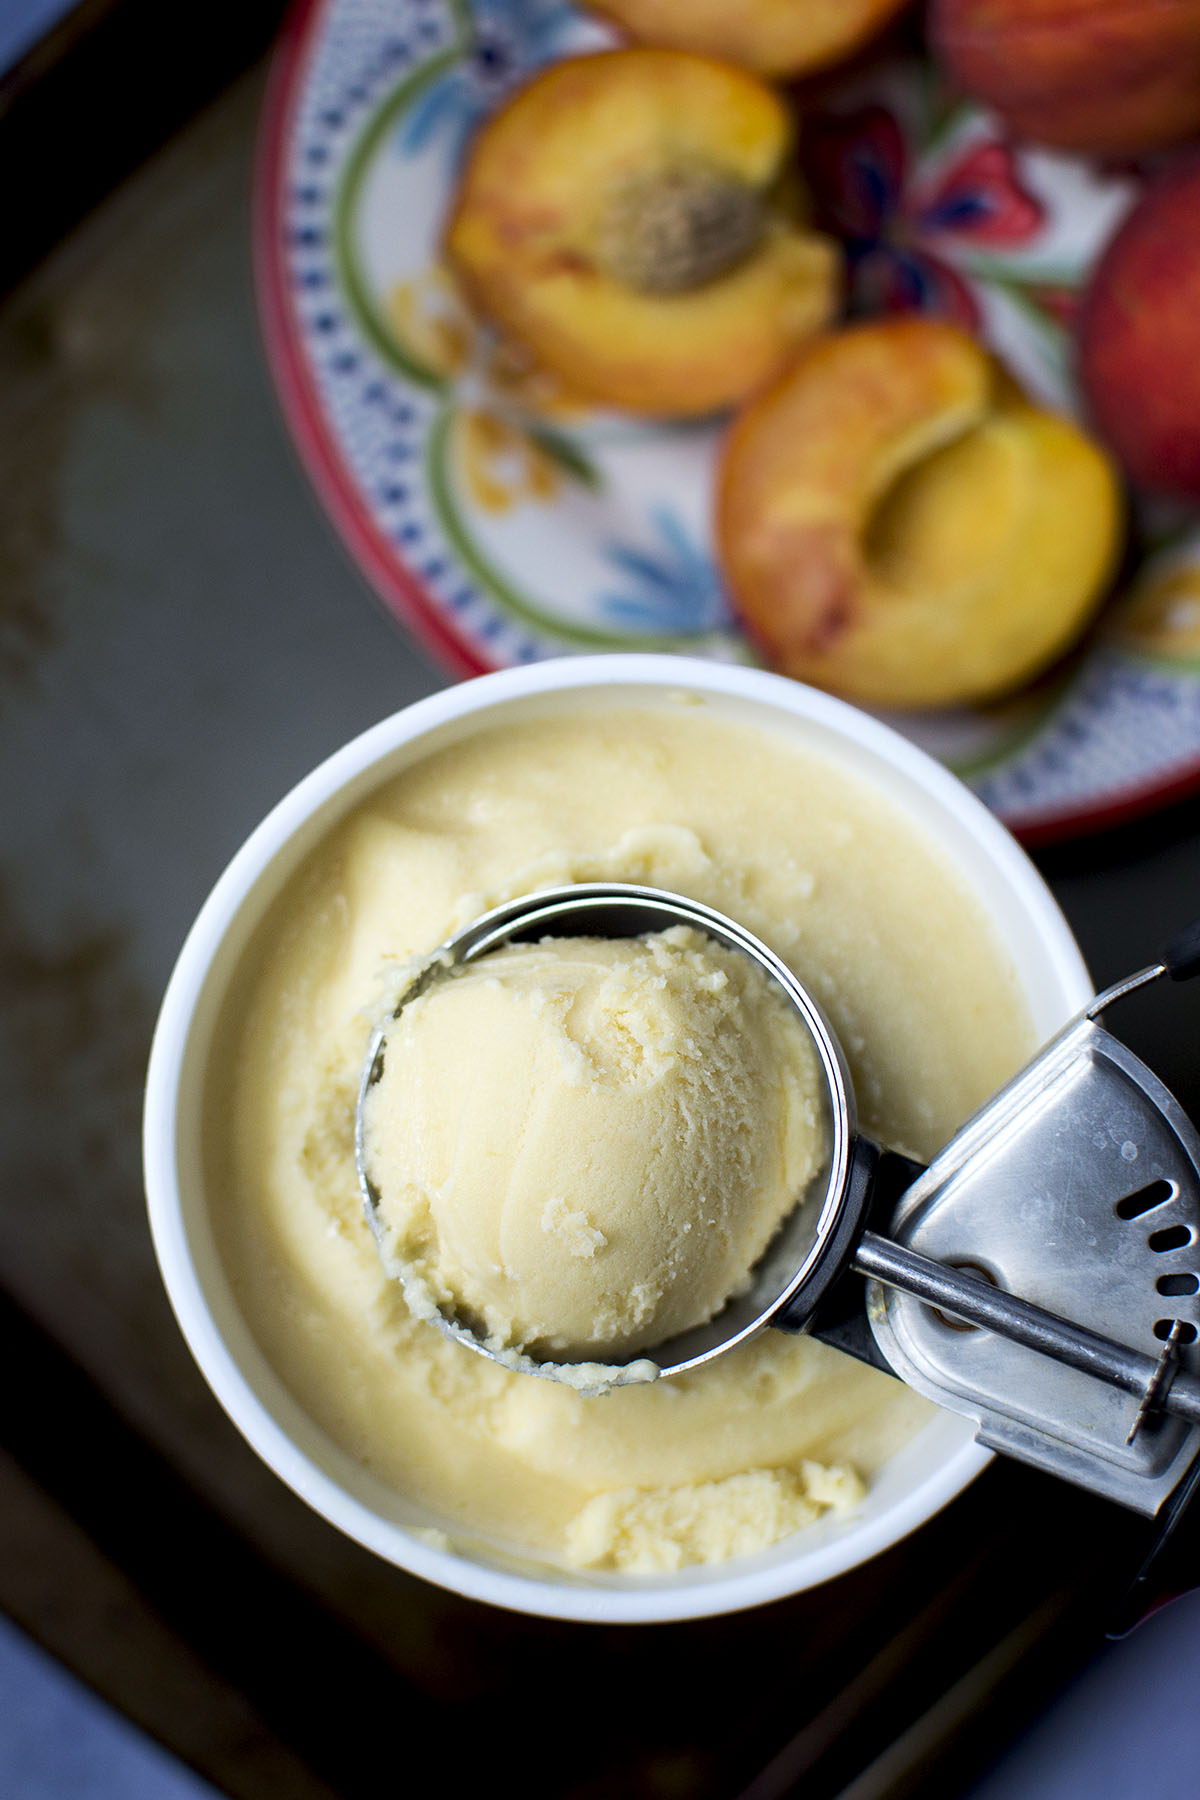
[[1079, 155, 1200, 497]]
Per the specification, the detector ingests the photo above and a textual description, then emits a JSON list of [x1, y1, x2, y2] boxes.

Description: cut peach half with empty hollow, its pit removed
[[718, 317, 1121, 709]]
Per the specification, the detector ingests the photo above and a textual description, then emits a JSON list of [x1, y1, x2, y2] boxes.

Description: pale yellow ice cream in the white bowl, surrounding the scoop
[[205, 695, 1033, 1571]]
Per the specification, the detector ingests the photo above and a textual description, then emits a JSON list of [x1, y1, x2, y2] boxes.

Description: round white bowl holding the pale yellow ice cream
[[144, 655, 1092, 1624]]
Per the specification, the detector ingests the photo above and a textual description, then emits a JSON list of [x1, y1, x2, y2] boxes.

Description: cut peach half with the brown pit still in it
[[446, 49, 840, 418]]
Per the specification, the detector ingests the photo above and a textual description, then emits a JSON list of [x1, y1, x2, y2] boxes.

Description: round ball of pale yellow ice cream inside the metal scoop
[[363, 927, 822, 1359]]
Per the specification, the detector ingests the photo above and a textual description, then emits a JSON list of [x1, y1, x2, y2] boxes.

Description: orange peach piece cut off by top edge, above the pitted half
[[588, 0, 909, 76]]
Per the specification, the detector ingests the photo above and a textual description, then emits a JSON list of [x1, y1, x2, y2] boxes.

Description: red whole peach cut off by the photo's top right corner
[[930, 0, 1200, 155]]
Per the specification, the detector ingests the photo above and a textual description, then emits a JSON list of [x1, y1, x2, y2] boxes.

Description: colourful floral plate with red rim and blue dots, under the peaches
[[257, 0, 1200, 842]]
